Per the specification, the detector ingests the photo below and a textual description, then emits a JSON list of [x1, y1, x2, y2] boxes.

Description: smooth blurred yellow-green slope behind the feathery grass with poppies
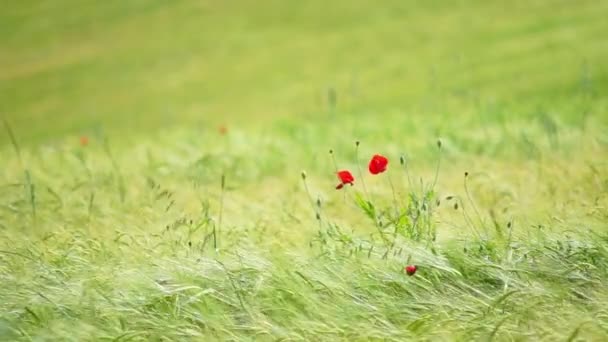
[[0, 0, 608, 143]]
